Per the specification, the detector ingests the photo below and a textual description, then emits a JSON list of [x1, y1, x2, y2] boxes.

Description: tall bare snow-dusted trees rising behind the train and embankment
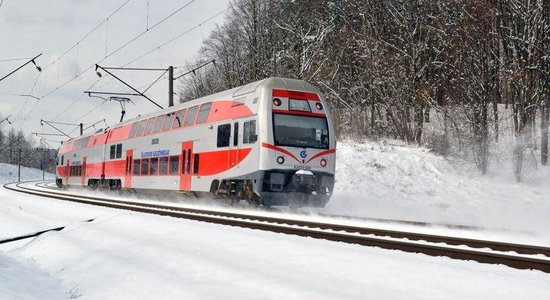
[[180, 0, 550, 181]]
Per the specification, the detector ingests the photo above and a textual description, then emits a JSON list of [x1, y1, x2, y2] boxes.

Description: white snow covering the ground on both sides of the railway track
[[0, 142, 550, 299]]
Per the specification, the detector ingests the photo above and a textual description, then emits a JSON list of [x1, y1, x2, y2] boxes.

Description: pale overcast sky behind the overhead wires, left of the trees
[[0, 0, 229, 146]]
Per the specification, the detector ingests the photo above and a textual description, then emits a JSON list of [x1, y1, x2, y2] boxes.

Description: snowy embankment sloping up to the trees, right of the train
[[324, 141, 550, 237]]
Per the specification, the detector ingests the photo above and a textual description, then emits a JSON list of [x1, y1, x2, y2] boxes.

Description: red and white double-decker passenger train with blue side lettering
[[56, 77, 336, 207]]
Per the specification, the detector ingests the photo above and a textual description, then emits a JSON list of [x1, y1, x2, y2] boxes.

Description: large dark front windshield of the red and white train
[[273, 114, 329, 149]]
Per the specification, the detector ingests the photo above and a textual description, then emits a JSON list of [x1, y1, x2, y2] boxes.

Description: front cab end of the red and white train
[[256, 82, 336, 207]]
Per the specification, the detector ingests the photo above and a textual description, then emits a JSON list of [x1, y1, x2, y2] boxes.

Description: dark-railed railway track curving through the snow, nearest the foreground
[[4, 183, 550, 273]]
